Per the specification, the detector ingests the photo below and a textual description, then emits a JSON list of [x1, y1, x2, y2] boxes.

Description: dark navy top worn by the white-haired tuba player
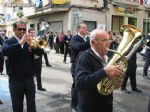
[[75, 49, 113, 112]]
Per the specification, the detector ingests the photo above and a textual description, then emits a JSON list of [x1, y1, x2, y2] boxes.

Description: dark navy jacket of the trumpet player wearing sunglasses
[[2, 37, 42, 81]]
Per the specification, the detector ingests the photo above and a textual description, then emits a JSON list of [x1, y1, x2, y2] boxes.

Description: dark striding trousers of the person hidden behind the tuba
[[121, 65, 136, 90]]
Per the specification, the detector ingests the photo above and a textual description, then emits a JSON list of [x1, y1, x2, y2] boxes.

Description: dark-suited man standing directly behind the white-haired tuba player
[[71, 23, 90, 112]]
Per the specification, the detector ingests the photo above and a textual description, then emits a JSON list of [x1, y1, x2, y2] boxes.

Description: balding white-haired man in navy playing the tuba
[[75, 29, 123, 112]]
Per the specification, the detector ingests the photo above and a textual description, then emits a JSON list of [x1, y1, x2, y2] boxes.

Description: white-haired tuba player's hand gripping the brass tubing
[[104, 65, 123, 76]]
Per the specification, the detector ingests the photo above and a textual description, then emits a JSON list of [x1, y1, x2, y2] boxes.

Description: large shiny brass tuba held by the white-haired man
[[97, 25, 146, 95]]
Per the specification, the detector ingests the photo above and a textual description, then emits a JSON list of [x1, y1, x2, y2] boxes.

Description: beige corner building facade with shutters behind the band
[[2, 0, 150, 35]]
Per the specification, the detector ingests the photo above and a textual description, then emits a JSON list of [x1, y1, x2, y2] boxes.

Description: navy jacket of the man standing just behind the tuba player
[[70, 34, 90, 63]]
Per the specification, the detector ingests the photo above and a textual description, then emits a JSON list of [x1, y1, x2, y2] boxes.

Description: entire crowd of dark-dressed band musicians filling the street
[[0, 21, 150, 112]]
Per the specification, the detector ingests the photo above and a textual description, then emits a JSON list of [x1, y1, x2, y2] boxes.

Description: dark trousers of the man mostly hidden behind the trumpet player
[[34, 56, 42, 88]]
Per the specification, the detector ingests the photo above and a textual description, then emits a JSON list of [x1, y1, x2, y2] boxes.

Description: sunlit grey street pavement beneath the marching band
[[0, 50, 150, 112]]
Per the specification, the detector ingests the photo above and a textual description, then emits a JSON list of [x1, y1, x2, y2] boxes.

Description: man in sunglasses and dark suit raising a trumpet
[[2, 21, 38, 112]]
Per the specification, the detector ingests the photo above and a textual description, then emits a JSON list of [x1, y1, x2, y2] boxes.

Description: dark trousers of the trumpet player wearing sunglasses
[[9, 78, 36, 112]]
